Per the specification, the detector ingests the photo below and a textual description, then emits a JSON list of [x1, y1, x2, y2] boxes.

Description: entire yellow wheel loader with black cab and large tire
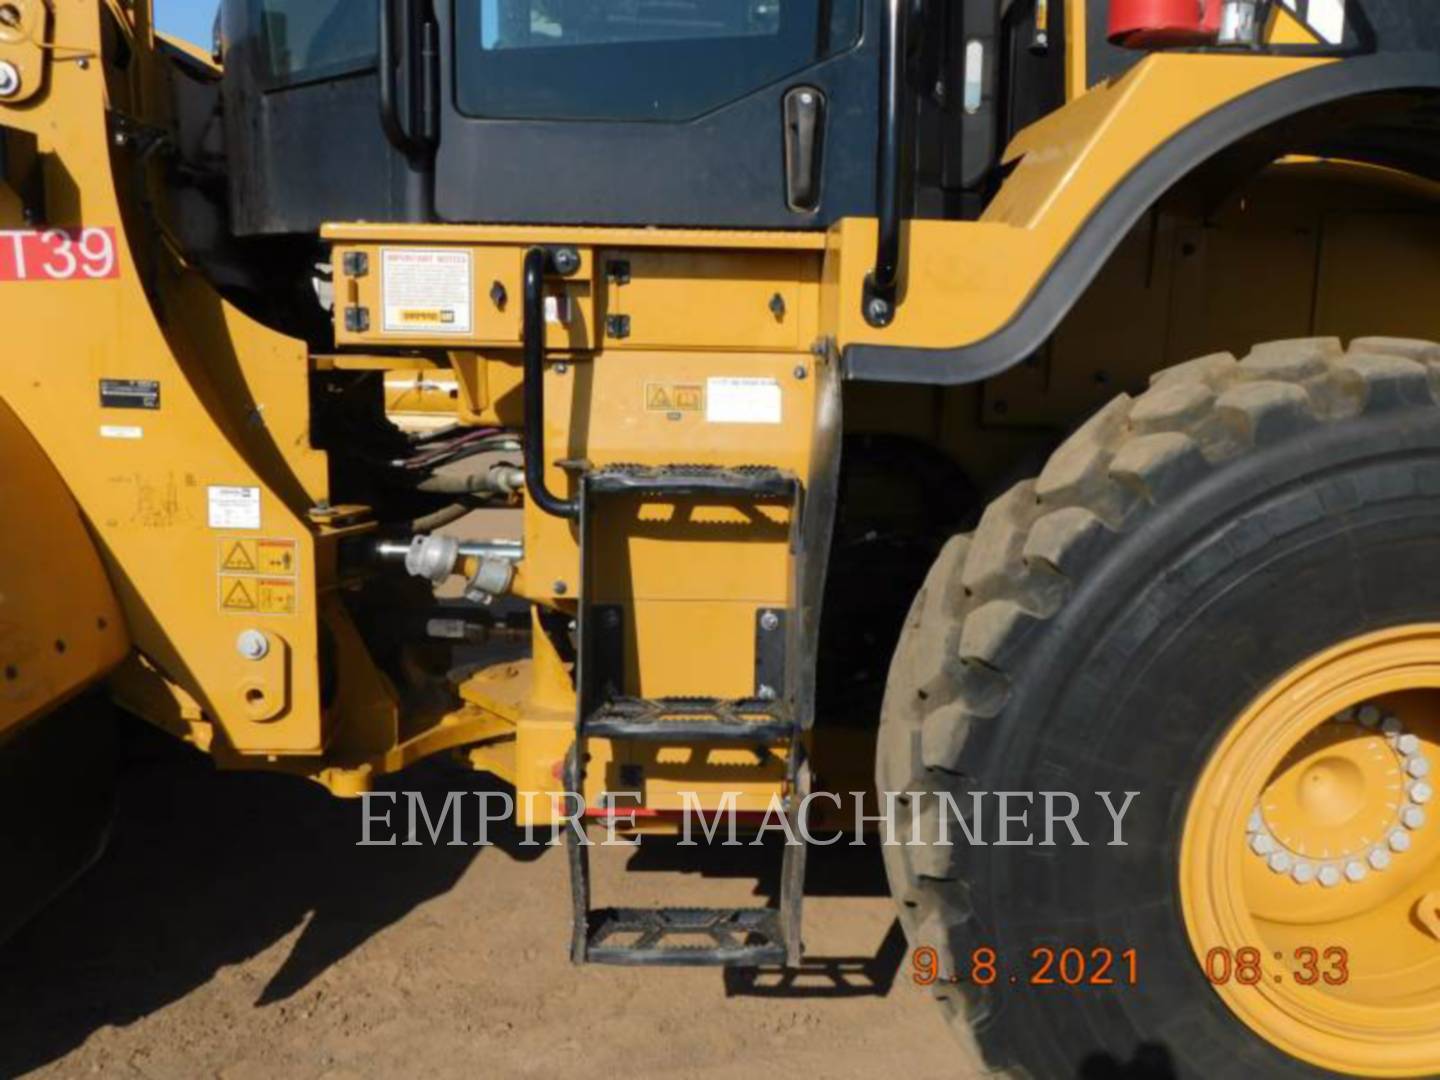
[[0, 0, 1440, 1077]]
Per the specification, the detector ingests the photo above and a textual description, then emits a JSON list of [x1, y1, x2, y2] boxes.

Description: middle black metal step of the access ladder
[[583, 697, 795, 744]]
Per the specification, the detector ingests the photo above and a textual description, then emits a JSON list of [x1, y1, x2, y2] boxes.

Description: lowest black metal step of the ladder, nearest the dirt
[[586, 907, 786, 968]]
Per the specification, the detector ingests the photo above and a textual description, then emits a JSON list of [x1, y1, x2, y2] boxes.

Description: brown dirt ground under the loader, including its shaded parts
[[0, 726, 973, 1080]]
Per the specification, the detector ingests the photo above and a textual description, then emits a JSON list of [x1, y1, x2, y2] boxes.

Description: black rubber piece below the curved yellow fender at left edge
[[0, 694, 115, 942]]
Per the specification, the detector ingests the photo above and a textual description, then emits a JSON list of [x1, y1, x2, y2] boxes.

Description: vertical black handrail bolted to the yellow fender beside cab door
[[863, 0, 912, 327]]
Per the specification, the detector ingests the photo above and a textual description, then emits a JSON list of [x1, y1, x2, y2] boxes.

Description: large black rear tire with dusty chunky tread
[[877, 338, 1440, 1080]]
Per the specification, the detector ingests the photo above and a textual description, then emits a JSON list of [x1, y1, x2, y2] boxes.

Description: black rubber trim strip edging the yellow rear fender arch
[[844, 52, 1440, 386]]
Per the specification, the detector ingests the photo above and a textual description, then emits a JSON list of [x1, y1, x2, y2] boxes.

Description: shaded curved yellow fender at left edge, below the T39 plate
[[0, 402, 130, 739]]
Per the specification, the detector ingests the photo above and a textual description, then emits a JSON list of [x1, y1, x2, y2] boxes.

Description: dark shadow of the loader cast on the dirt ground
[[0, 720, 904, 1077]]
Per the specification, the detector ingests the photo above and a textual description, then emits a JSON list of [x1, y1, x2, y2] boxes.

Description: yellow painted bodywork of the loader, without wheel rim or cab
[[0, 0, 1440, 809]]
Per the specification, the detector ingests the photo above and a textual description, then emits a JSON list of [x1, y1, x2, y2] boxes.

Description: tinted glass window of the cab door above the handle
[[455, 0, 860, 121]]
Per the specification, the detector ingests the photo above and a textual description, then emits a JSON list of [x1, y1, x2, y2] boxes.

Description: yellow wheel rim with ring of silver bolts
[[1181, 625, 1440, 1076]]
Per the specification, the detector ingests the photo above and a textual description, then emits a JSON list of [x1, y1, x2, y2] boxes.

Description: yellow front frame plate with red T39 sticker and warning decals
[[0, 0, 345, 755]]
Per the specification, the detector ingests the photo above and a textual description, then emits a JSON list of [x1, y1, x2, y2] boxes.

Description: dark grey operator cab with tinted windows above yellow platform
[[222, 0, 878, 235]]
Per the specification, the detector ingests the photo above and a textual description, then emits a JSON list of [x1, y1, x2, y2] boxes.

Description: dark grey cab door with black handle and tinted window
[[433, 0, 878, 228]]
